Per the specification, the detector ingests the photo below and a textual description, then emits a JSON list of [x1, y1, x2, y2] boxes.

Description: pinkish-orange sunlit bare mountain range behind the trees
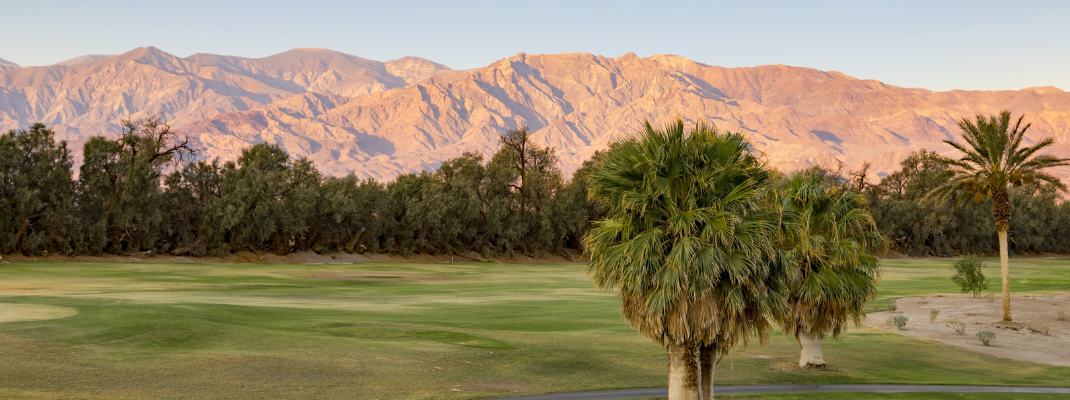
[[0, 47, 1070, 180]]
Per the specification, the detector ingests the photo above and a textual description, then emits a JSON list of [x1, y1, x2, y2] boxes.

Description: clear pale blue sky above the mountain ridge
[[0, 0, 1070, 90]]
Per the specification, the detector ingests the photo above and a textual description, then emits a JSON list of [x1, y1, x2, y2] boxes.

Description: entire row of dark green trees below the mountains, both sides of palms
[[0, 119, 1070, 257]]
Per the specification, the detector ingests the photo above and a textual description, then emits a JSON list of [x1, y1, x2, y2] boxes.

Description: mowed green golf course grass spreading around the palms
[[0, 259, 1070, 399]]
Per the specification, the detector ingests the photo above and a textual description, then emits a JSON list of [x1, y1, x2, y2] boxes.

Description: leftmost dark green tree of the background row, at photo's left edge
[[0, 124, 75, 255]]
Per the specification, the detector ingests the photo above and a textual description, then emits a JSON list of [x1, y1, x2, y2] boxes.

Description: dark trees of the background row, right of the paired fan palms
[[853, 151, 1070, 256]]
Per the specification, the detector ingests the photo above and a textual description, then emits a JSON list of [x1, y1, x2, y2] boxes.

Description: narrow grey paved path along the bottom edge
[[503, 385, 1070, 400]]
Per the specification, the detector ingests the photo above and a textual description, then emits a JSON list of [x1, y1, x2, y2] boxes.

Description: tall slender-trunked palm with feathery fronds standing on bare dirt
[[926, 111, 1070, 322]]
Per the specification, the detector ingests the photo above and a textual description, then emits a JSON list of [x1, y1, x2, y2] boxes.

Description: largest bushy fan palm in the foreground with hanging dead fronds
[[584, 121, 782, 400]]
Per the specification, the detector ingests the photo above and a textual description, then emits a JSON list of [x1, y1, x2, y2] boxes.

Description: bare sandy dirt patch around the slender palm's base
[[866, 294, 1070, 367]]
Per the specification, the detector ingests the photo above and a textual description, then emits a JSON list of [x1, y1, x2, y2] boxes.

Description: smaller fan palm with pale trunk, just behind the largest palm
[[776, 170, 882, 368]]
